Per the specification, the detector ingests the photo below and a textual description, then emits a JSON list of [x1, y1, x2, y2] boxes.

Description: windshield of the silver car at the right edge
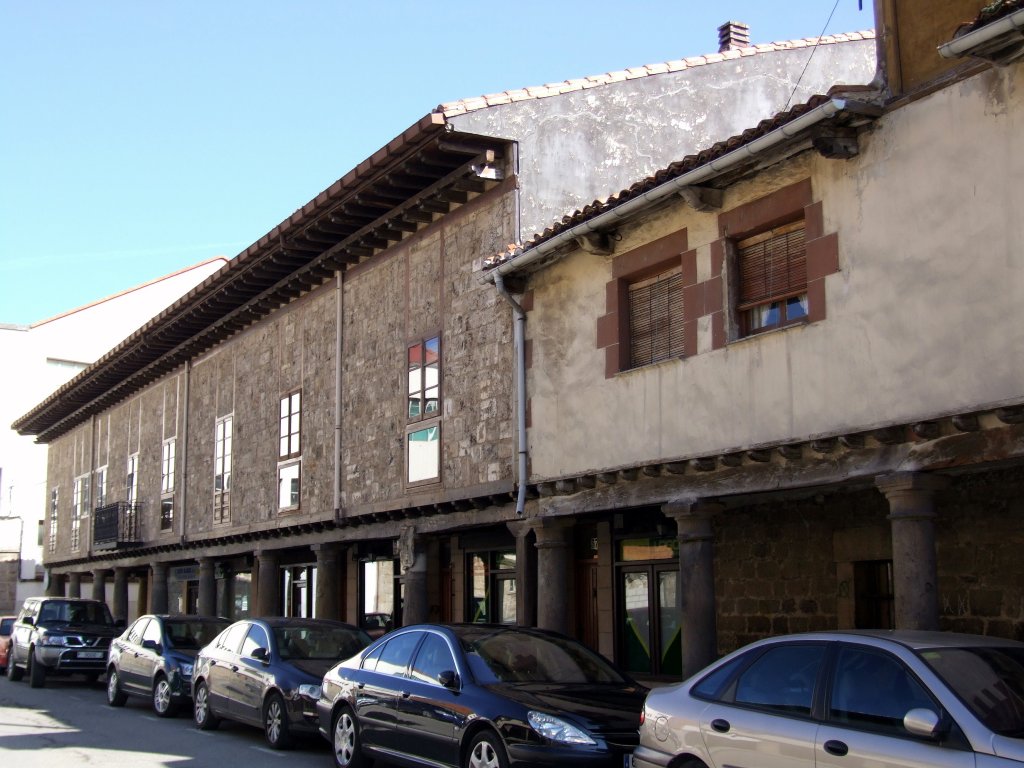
[[921, 647, 1024, 737]]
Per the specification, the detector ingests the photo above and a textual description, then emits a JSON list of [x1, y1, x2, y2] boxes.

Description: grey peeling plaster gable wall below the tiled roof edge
[[449, 39, 876, 242]]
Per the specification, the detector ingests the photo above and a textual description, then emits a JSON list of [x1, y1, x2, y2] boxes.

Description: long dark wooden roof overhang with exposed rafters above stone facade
[[12, 113, 508, 442]]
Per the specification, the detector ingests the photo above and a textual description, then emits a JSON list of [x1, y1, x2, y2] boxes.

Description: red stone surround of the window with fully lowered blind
[[597, 229, 687, 378]]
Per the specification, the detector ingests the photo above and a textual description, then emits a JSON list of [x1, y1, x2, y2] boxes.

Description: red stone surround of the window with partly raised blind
[[712, 179, 839, 349]]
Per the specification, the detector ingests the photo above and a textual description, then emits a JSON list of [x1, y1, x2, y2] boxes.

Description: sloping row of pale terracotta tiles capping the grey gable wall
[[434, 29, 876, 118]]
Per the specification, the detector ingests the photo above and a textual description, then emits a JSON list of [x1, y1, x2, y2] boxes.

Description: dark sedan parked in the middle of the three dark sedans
[[193, 618, 370, 750]]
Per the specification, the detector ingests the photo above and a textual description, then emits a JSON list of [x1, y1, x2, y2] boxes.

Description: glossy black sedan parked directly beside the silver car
[[316, 624, 646, 768]]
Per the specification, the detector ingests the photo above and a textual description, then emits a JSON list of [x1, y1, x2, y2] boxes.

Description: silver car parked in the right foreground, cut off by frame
[[633, 631, 1024, 768]]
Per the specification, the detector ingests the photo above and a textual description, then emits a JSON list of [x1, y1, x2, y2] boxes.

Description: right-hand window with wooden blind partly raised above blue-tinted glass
[[735, 219, 807, 336]]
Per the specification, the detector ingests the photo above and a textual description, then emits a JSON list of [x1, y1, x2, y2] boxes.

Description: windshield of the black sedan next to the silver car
[[461, 630, 626, 684]]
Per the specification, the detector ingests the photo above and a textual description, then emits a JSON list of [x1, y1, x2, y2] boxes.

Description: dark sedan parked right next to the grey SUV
[[106, 615, 230, 718]]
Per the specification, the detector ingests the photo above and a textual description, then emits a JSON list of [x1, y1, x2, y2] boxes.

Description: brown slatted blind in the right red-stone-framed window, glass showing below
[[736, 221, 807, 309]]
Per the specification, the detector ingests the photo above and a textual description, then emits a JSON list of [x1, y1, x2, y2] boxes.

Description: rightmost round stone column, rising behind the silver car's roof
[[876, 472, 949, 630]]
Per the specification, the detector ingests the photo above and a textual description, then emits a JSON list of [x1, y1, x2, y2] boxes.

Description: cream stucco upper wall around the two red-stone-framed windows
[[527, 66, 1024, 479]]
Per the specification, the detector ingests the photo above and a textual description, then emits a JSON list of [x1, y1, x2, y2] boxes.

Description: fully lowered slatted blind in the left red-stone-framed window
[[629, 269, 683, 368]]
